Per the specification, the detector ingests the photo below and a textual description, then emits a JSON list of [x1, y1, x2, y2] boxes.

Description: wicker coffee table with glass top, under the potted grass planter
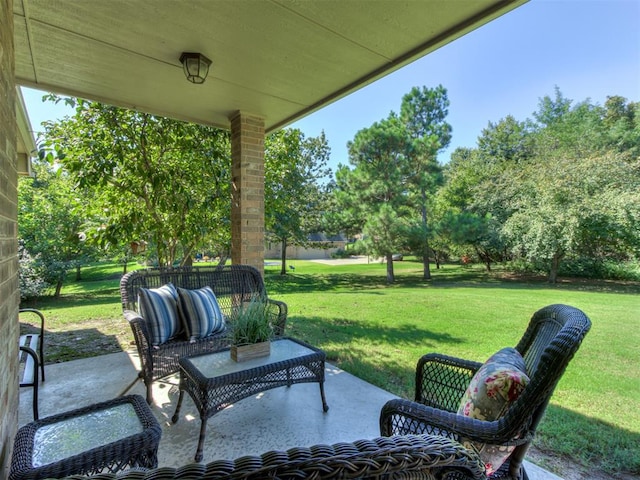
[[172, 338, 329, 462]]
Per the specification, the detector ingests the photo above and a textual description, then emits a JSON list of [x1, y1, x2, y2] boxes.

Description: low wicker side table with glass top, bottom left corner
[[9, 395, 162, 480]]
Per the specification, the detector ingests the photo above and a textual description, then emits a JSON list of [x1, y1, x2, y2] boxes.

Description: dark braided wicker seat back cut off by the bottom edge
[[58, 435, 486, 480]]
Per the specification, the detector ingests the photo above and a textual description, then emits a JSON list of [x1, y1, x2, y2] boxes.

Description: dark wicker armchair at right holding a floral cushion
[[380, 305, 591, 479]]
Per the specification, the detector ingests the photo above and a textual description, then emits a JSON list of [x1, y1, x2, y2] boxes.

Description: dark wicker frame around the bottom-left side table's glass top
[[9, 395, 162, 480]]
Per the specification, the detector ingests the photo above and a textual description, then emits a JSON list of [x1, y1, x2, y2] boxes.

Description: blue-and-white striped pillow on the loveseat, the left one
[[138, 283, 181, 346]]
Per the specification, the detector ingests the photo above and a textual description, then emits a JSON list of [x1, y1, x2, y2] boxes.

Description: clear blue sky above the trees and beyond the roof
[[24, 0, 640, 170]]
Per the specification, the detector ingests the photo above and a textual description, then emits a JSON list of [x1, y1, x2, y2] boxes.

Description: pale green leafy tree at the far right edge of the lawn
[[502, 89, 639, 282]]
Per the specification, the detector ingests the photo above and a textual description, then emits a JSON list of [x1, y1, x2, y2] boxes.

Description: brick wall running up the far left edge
[[0, 0, 20, 478]]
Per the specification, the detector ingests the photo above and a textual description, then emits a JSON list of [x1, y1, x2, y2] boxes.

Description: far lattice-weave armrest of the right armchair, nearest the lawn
[[415, 353, 482, 412]]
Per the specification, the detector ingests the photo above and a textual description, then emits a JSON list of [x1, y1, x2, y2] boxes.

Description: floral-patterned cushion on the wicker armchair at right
[[458, 348, 529, 475]]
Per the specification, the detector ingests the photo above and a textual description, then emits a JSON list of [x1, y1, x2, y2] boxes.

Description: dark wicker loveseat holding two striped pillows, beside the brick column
[[120, 265, 287, 403]]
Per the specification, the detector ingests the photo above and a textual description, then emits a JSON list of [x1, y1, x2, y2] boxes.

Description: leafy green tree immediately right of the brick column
[[265, 129, 331, 275]]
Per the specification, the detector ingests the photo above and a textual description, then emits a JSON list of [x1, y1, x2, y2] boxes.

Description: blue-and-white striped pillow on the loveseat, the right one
[[178, 287, 225, 341]]
